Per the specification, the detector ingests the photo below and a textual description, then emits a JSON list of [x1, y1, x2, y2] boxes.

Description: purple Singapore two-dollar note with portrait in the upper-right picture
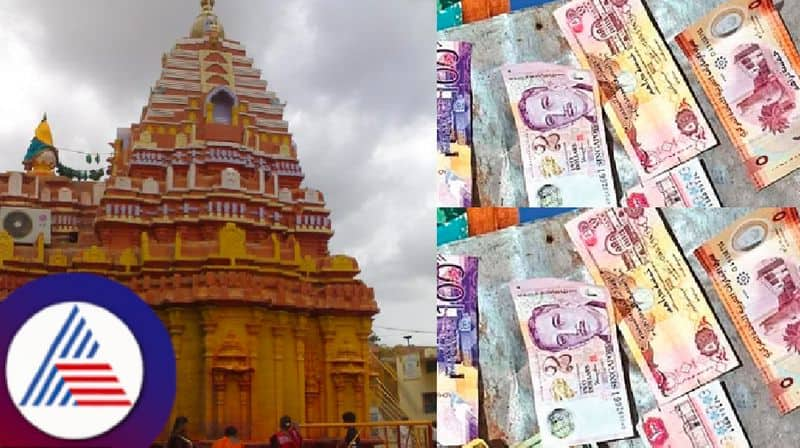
[[501, 62, 617, 207]]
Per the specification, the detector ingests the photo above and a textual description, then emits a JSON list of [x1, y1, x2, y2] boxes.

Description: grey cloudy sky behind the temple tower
[[0, 0, 436, 345]]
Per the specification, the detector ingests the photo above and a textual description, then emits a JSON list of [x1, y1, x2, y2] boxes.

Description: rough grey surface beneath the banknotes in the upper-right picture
[[439, 0, 800, 206]]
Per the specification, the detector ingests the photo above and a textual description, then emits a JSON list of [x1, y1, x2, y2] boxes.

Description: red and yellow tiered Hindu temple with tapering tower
[[0, 0, 378, 440]]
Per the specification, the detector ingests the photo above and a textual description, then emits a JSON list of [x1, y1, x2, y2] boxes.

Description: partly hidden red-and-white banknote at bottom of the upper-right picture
[[625, 158, 720, 208]]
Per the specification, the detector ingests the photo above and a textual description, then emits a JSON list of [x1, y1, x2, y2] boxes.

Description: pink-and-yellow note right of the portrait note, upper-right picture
[[554, 0, 717, 181]]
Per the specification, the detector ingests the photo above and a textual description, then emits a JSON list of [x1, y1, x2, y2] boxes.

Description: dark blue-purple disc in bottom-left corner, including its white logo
[[0, 274, 176, 448]]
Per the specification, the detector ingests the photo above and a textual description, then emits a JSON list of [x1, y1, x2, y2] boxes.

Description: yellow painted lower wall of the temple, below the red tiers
[[157, 305, 371, 441]]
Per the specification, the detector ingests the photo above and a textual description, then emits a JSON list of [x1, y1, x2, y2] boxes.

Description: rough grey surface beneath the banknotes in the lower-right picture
[[439, 208, 800, 448]]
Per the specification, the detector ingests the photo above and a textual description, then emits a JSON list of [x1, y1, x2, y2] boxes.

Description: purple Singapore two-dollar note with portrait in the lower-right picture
[[509, 278, 633, 447]]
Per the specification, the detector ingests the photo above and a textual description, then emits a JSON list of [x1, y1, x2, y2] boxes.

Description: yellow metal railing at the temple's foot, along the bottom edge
[[300, 420, 435, 448]]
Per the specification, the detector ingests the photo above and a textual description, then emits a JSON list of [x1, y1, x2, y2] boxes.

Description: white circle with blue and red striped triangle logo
[[6, 302, 144, 439]]
